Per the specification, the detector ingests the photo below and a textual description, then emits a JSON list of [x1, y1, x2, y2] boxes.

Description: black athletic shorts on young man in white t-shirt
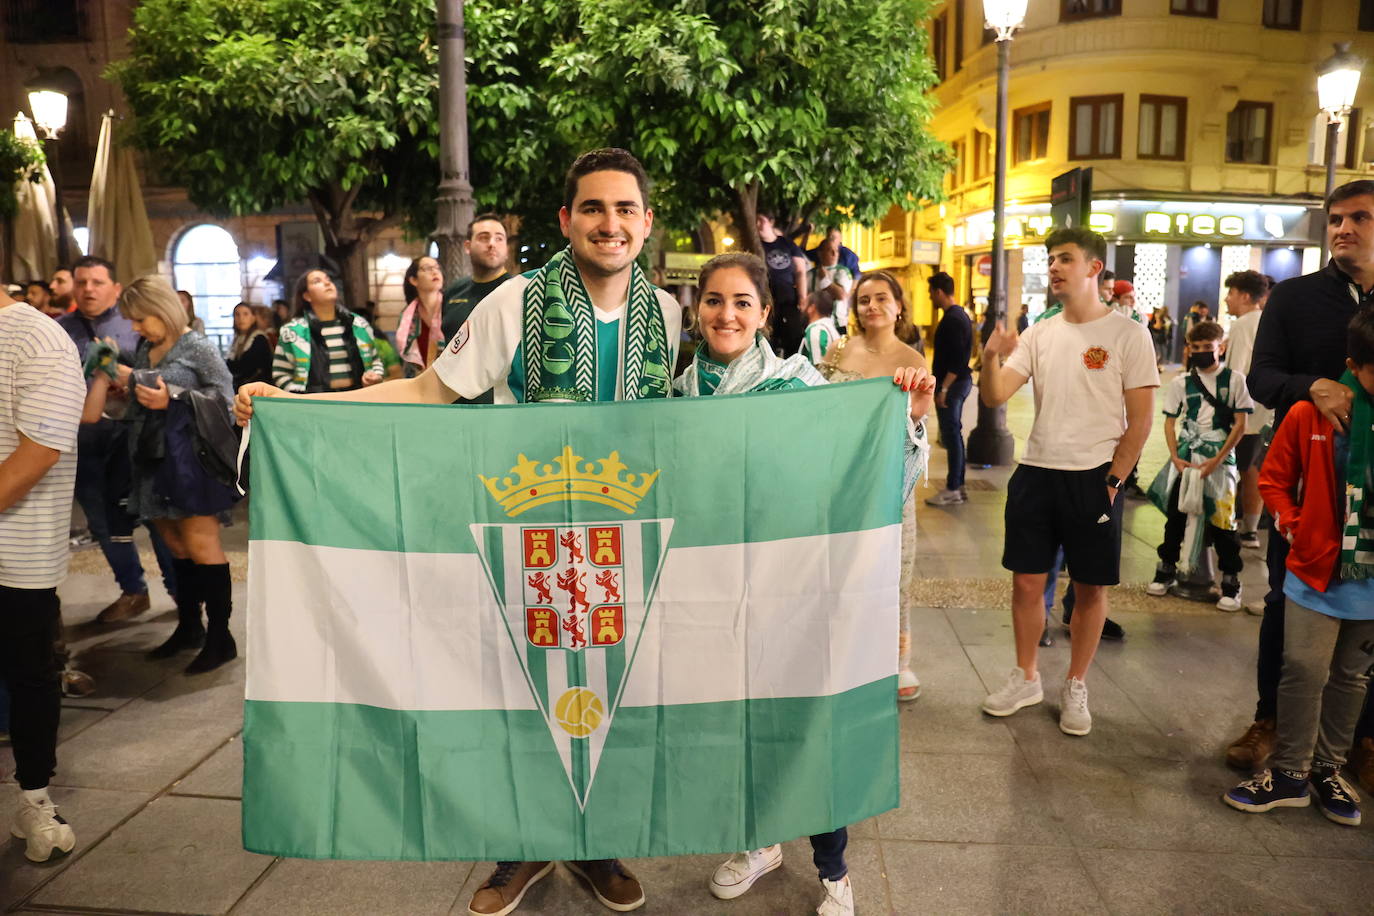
[[1002, 464, 1125, 585]]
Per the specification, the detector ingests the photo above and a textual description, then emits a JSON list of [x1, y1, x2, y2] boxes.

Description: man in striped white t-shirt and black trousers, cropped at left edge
[[0, 291, 85, 862]]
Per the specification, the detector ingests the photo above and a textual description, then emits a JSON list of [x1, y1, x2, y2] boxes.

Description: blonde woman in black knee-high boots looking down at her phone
[[85, 276, 238, 674]]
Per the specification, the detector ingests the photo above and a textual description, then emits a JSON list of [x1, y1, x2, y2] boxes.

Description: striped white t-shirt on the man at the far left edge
[[0, 305, 85, 589]]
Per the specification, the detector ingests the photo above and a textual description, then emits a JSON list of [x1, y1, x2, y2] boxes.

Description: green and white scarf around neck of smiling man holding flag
[[523, 247, 672, 402]]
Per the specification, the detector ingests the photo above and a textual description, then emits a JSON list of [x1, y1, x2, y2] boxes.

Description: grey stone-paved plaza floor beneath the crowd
[[0, 379, 1374, 916]]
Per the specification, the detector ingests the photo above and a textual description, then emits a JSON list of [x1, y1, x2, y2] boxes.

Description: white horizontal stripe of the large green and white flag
[[247, 525, 901, 710]]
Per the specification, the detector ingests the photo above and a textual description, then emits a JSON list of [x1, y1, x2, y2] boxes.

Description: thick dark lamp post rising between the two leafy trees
[[434, 0, 474, 283]]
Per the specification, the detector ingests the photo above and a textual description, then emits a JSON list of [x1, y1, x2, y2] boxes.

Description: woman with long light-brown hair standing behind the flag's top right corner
[[818, 271, 929, 700]]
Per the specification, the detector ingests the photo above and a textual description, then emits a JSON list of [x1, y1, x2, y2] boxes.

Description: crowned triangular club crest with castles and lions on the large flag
[[471, 446, 673, 808]]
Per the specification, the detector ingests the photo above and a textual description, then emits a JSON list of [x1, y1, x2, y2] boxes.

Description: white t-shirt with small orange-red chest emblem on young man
[[1006, 310, 1160, 471]]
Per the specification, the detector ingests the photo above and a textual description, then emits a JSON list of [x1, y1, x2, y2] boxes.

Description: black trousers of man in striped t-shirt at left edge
[[0, 585, 62, 788]]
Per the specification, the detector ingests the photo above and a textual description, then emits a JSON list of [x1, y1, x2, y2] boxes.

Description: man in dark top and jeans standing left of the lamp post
[[926, 271, 973, 505]]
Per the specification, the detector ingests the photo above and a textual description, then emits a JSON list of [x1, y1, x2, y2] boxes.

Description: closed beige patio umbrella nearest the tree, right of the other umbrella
[[87, 111, 158, 283]]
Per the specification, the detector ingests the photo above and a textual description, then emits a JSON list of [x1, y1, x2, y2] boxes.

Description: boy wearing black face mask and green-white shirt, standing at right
[[1146, 321, 1254, 611]]
